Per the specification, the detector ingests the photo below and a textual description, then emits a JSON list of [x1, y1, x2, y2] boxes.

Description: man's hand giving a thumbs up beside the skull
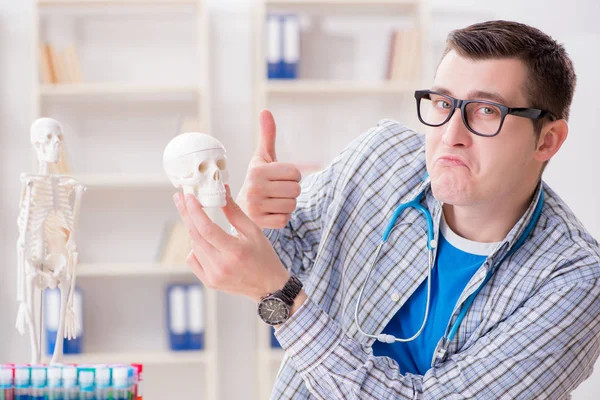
[[236, 110, 302, 229]]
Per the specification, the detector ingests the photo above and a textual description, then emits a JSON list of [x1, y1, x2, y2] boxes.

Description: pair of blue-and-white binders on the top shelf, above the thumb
[[265, 14, 300, 79]]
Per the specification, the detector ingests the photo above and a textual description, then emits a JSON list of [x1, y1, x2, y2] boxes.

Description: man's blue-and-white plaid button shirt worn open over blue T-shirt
[[265, 120, 600, 400]]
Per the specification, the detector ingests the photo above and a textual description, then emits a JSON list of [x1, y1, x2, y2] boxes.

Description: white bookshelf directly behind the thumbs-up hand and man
[[254, 0, 431, 399]]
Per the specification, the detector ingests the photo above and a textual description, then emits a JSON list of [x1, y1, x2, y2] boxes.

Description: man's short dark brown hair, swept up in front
[[442, 20, 577, 133]]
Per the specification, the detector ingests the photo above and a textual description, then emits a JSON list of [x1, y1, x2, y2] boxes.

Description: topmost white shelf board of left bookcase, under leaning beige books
[[40, 83, 200, 97]]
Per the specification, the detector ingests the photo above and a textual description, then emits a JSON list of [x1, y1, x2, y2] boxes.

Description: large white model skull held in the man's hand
[[163, 132, 229, 207]]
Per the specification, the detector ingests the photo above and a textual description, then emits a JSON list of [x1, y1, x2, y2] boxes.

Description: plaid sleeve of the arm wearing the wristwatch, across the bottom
[[276, 260, 600, 400]]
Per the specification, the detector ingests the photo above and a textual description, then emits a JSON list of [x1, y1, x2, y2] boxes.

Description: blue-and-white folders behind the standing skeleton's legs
[[44, 288, 83, 356]]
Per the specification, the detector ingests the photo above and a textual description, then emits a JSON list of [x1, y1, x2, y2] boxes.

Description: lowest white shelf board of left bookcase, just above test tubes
[[44, 350, 211, 365]]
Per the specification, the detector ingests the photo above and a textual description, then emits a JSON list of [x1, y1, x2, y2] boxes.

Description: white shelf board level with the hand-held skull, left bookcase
[[74, 173, 175, 190]]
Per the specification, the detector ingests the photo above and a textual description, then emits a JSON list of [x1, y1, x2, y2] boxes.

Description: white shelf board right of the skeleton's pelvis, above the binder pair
[[77, 263, 192, 277]]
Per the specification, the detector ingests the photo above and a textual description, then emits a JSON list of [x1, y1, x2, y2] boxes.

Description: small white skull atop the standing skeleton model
[[30, 118, 63, 164]]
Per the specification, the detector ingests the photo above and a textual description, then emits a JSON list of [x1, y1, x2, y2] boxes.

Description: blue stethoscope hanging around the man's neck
[[354, 180, 544, 358]]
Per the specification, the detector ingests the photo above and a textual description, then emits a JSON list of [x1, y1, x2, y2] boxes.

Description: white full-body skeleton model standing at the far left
[[16, 118, 85, 364]]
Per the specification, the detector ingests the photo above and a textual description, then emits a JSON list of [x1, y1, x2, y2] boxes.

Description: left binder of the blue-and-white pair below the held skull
[[167, 284, 188, 351]]
